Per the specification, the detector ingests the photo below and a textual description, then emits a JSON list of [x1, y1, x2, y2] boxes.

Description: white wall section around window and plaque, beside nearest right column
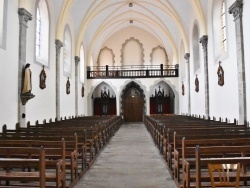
[[207, 0, 239, 122]]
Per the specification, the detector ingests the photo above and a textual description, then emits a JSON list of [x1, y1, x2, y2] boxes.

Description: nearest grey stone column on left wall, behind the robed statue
[[18, 8, 32, 127]]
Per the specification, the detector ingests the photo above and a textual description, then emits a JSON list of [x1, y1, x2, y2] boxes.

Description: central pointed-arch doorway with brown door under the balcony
[[121, 82, 145, 122]]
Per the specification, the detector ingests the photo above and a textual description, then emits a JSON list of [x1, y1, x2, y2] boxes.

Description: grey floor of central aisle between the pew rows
[[75, 123, 177, 188]]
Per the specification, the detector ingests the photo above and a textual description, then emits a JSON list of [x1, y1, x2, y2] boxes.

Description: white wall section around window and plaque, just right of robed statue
[[26, 1, 56, 124]]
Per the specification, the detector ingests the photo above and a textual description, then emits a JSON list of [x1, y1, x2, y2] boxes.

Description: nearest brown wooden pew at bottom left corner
[[0, 147, 66, 188]]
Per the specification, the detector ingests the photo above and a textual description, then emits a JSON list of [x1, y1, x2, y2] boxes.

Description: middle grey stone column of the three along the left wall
[[55, 39, 63, 121]]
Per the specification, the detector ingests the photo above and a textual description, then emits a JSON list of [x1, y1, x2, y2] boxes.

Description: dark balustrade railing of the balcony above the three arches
[[87, 64, 179, 79]]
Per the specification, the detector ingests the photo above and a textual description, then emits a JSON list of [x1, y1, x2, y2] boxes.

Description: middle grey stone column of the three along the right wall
[[200, 35, 209, 119]]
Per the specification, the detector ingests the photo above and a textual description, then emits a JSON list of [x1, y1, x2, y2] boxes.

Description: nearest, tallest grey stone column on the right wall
[[228, 0, 247, 124]]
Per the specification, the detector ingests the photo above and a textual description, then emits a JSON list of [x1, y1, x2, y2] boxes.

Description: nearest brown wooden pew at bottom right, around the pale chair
[[179, 146, 250, 188]]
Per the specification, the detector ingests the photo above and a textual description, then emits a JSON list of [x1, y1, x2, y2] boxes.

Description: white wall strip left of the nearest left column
[[0, 0, 19, 129]]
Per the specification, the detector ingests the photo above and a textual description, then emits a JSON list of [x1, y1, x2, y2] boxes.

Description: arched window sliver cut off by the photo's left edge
[[0, 0, 7, 49]]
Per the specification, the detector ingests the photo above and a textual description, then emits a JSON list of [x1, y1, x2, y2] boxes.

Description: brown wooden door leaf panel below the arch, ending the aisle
[[124, 96, 143, 122]]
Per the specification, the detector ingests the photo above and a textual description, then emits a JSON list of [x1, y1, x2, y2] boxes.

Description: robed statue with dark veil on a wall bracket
[[21, 63, 35, 105]]
